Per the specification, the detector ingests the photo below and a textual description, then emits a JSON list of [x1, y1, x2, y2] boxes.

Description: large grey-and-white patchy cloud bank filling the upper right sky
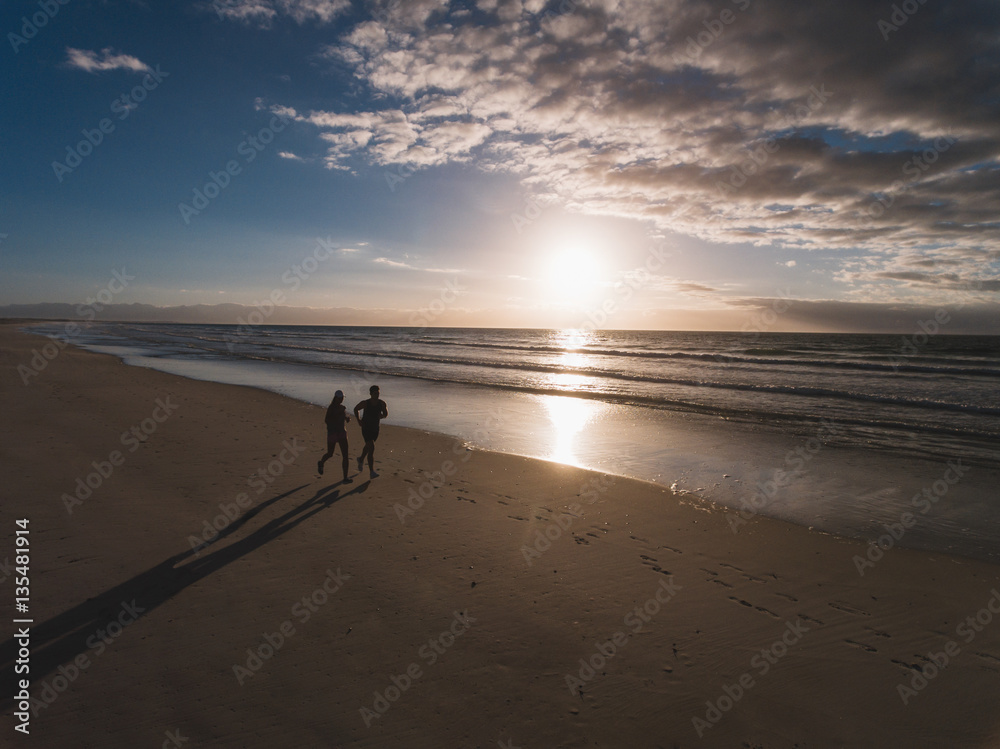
[[276, 0, 1000, 298]]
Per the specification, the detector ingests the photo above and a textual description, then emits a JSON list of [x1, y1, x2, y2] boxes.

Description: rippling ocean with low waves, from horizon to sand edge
[[21, 323, 1000, 561]]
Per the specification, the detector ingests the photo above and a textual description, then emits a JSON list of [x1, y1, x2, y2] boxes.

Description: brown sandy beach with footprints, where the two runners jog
[[0, 325, 1000, 749]]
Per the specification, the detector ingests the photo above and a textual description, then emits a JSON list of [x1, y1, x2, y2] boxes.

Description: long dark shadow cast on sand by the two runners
[[0, 481, 370, 698]]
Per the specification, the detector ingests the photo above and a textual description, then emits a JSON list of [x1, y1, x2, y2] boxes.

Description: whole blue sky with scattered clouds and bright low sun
[[0, 0, 1000, 333]]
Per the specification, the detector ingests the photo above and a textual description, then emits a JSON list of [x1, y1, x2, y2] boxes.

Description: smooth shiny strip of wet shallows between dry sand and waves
[[17, 318, 1000, 564]]
